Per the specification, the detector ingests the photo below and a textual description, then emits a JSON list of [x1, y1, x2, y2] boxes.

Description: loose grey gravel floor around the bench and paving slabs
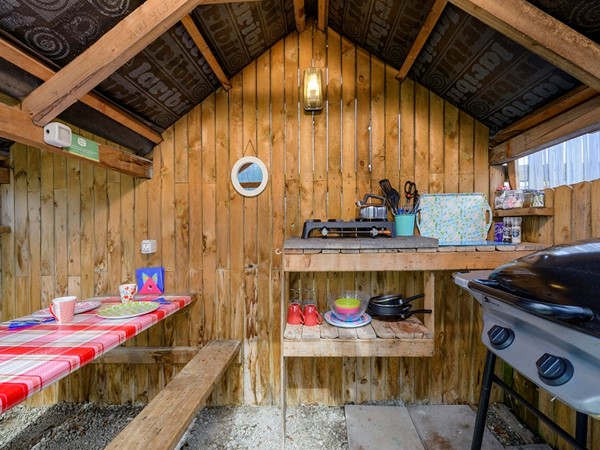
[[0, 403, 523, 450]]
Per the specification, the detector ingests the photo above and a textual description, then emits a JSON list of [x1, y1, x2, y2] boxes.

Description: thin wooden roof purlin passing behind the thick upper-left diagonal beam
[[0, 37, 162, 144]]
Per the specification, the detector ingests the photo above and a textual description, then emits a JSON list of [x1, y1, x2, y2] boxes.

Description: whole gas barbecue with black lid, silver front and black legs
[[454, 239, 600, 449]]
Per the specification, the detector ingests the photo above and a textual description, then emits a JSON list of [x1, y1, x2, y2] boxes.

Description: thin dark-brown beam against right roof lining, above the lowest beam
[[492, 85, 598, 145]]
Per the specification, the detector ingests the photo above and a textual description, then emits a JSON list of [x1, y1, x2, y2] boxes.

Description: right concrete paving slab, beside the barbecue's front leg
[[407, 405, 504, 450]]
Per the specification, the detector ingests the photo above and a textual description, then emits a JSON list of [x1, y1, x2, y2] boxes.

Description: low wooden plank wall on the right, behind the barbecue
[[516, 180, 600, 450]]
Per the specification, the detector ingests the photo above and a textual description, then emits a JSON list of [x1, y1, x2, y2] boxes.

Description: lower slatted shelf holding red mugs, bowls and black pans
[[283, 317, 434, 357]]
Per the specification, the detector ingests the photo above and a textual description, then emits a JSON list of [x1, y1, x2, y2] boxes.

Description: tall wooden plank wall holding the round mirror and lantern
[[0, 26, 496, 412]]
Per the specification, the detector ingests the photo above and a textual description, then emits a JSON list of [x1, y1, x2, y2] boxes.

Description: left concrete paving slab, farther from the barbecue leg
[[345, 405, 425, 450]]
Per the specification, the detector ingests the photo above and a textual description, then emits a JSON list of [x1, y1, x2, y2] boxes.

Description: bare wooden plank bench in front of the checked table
[[106, 340, 241, 450]]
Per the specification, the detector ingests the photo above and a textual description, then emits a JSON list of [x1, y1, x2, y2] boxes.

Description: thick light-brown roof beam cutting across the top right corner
[[450, 0, 600, 92]]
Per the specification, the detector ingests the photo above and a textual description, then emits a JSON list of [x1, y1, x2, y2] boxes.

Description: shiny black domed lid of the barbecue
[[488, 239, 600, 312]]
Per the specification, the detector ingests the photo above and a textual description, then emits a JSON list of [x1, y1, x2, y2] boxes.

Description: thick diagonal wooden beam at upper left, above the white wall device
[[22, 0, 246, 126]]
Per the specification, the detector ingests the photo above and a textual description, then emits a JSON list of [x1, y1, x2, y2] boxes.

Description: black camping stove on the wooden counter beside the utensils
[[302, 219, 394, 239]]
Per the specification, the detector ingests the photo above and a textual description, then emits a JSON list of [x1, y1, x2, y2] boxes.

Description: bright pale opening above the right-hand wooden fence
[[516, 132, 600, 189]]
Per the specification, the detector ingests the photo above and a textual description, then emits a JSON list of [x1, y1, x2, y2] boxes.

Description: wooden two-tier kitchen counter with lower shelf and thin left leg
[[280, 237, 548, 442]]
